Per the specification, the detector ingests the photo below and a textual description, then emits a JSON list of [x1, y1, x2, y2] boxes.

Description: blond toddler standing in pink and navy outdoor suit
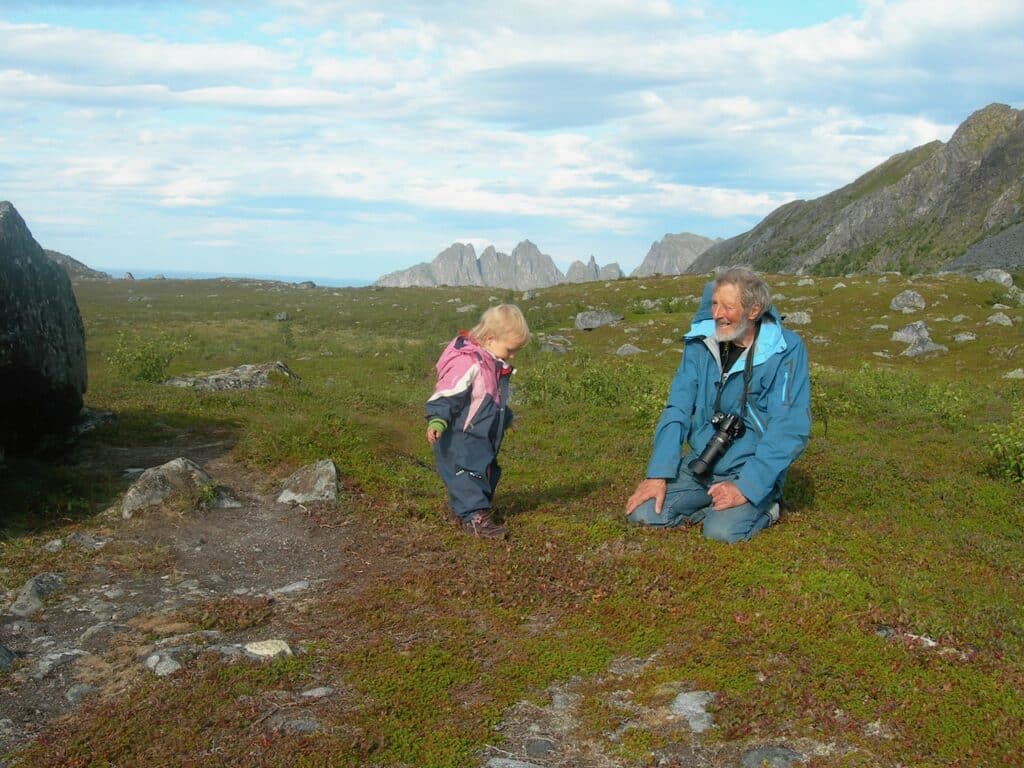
[[426, 304, 529, 539]]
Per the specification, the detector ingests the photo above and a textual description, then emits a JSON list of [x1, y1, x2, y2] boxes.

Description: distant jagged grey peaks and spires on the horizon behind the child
[[375, 240, 622, 291]]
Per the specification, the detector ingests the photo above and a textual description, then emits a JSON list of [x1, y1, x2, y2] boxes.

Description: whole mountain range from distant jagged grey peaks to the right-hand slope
[[377, 103, 1024, 289]]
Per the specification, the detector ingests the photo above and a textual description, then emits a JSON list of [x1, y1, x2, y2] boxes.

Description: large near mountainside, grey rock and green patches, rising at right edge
[[689, 104, 1024, 274]]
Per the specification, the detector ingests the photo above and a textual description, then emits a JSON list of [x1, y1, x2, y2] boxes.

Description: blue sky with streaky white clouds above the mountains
[[0, 0, 1024, 281]]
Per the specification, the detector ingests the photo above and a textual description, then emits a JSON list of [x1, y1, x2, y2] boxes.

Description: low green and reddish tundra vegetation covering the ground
[[0, 274, 1024, 766]]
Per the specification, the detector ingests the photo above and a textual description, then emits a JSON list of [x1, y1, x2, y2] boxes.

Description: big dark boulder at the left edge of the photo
[[0, 202, 86, 453]]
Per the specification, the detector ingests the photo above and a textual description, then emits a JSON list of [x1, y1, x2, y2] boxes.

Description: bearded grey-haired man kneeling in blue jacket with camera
[[626, 267, 811, 543]]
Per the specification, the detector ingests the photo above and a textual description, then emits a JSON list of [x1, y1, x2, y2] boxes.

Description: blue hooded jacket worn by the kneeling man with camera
[[647, 284, 811, 506]]
